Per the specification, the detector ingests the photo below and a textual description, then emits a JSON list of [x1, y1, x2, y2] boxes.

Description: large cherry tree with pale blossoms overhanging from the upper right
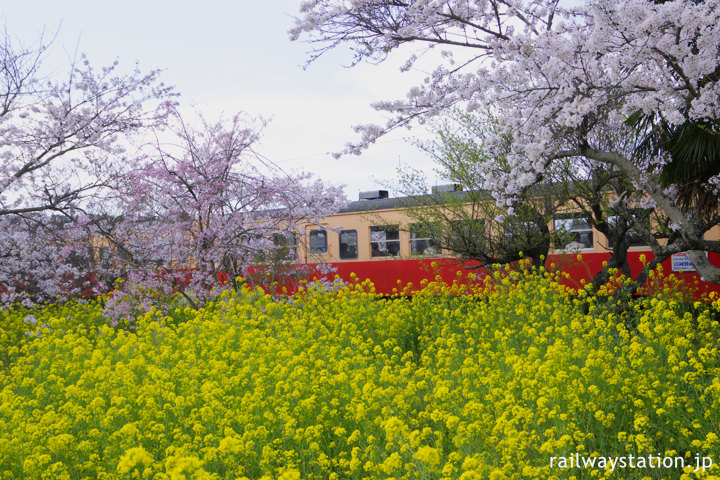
[[290, 0, 720, 283]]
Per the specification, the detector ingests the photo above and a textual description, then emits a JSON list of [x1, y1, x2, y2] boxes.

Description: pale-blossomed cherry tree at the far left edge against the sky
[[0, 30, 174, 215]]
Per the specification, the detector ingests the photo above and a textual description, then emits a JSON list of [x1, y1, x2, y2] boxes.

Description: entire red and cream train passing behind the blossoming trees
[[5, 184, 720, 298]]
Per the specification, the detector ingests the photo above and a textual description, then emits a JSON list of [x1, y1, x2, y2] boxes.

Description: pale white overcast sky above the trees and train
[[0, 0, 436, 200]]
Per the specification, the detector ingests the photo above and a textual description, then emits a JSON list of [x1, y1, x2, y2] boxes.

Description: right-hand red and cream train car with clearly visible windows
[[297, 186, 720, 295]]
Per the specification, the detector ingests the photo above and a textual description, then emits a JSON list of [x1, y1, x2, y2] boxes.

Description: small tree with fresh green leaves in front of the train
[[393, 109, 570, 267]]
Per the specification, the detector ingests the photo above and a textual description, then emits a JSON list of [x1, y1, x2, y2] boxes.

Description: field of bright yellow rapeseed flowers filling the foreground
[[0, 271, 720, 480]]
